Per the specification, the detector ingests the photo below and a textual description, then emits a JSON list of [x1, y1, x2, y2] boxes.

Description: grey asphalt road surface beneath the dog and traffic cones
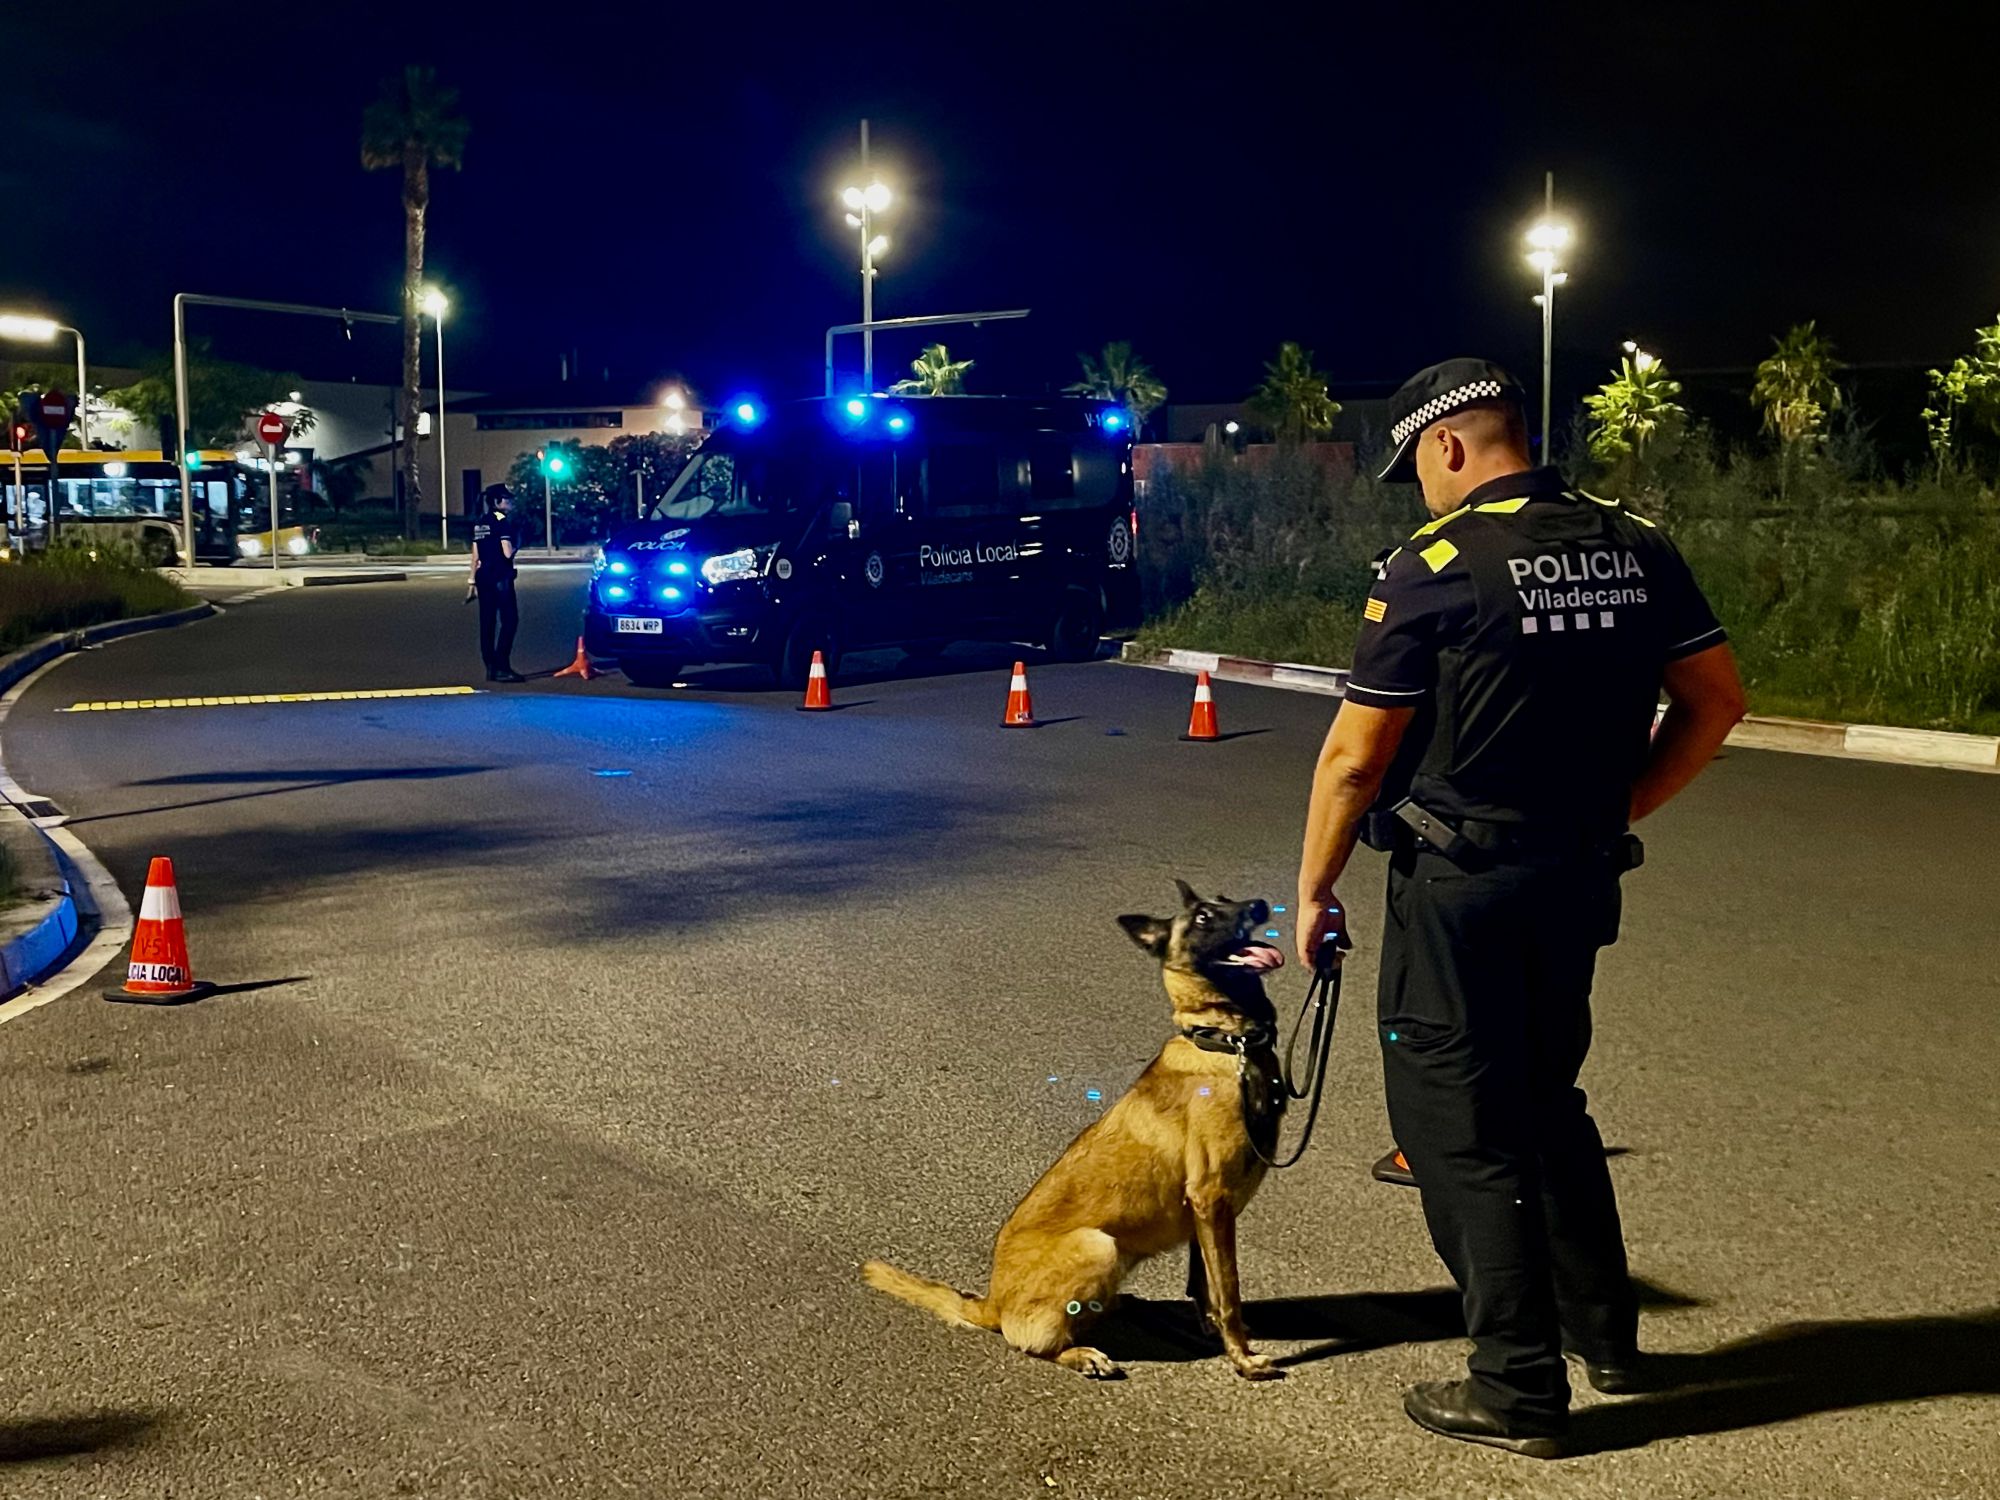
[[0, 572, 2000, 1500]]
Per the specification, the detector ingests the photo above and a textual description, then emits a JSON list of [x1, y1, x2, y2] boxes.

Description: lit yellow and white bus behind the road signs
[[0, 448, 270, 566]]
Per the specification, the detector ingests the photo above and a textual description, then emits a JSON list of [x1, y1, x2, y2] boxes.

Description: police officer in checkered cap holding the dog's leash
[[1298, 360, 1744, 1458]]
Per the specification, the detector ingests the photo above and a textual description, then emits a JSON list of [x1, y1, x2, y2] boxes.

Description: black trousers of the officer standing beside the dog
[[1378, 850, 1638, 1428]]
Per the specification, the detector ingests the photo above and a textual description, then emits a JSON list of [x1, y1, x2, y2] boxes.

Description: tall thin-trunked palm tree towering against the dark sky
[[362, 66, 472, 536]]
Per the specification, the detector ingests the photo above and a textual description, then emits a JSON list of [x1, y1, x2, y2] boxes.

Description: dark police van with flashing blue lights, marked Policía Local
[[584, 396, 1138, 686]]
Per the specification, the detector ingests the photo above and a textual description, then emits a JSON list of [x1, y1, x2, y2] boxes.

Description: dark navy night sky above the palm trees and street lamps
[[0, 0, 2000, 424]]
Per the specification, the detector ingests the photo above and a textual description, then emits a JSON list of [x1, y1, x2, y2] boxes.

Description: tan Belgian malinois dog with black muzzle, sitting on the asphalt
[[862, 880, 1284, 1380]]
